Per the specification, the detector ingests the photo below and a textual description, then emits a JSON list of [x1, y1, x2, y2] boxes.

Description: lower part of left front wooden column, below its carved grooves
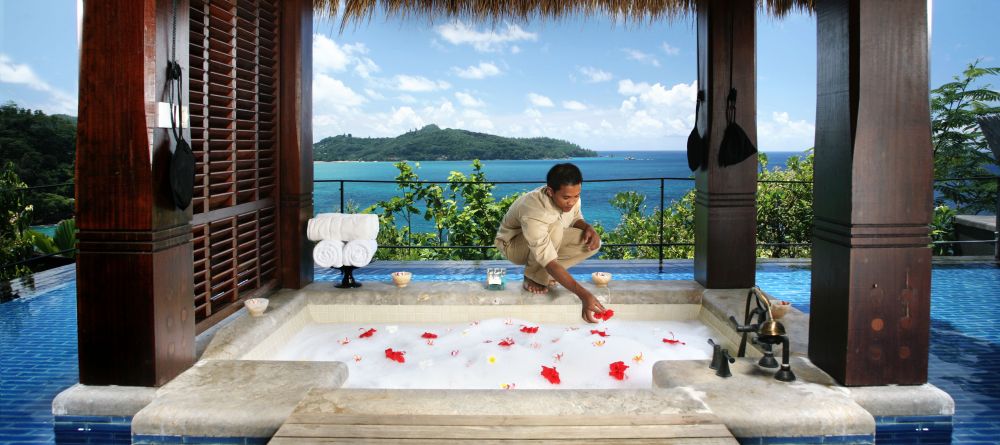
[[77, 224, 195, 386]]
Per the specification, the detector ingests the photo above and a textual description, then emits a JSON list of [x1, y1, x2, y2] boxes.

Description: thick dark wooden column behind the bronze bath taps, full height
[[809, 0, 933, 386]]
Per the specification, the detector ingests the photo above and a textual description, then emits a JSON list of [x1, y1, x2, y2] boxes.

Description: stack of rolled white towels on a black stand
[[306, 213, 378, 267]]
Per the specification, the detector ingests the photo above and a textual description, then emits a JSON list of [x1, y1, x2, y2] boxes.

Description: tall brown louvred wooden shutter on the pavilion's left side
[[189, 0, 279, 332]]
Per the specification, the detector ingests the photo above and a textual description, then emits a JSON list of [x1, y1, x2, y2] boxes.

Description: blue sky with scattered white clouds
[[0, 0, 1000, 151]]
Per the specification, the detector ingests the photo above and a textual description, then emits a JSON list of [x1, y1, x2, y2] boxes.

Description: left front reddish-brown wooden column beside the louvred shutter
[[76, 0, 194, 386]]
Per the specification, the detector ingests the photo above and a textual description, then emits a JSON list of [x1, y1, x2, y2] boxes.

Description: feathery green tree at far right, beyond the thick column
[[931, 60, 1000, 214]]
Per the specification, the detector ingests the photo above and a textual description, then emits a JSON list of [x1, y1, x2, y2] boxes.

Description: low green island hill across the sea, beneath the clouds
[[313, 124, 597, 161]]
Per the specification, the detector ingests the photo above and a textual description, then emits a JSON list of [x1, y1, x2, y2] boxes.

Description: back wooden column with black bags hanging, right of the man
[[694, 0, 757, 289]]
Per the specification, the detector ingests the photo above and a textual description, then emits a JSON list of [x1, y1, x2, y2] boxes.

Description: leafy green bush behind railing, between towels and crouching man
[[363, 160, 519, 260]]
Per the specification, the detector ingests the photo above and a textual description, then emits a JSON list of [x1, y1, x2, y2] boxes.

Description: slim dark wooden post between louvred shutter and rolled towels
[[278, 0, 313, 289]]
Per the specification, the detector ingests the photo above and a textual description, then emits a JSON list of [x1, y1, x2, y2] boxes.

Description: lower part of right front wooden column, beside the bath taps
[[809, 224, 931, 386]]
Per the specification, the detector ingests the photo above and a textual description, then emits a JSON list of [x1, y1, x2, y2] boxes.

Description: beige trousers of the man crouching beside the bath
[[496, 227, 601, 286]]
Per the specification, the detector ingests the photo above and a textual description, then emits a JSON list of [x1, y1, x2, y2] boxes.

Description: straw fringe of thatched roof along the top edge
[[313, 0, 814, 27]]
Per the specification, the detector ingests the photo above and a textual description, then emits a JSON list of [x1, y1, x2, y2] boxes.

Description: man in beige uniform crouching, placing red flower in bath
[[496, 163, 604, 323]]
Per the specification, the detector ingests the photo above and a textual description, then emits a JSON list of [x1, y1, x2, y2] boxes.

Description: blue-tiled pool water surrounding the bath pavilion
[[0, 262, 1000, 445]]
